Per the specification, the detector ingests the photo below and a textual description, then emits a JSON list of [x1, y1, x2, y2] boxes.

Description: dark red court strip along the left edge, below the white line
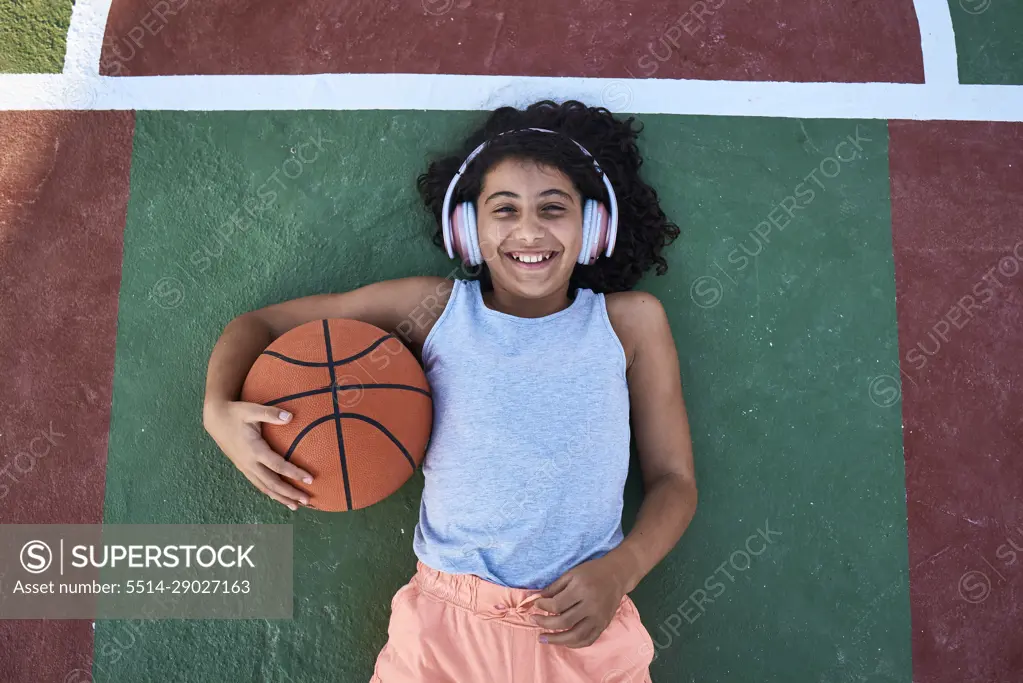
[[0, 111, 135, 683]]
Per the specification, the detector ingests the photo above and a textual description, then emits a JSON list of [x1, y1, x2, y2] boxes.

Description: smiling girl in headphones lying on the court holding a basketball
[[204, 101, 697, 683]]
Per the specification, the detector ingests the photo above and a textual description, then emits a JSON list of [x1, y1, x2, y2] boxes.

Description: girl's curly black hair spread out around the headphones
[[416, 100, 679, 293]]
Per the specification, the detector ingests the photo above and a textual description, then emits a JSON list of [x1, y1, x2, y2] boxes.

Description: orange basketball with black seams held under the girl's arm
[[241, 319, 433, 512]]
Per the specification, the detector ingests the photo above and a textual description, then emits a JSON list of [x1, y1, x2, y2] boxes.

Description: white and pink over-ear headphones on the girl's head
[[441, 128, 618, 266]]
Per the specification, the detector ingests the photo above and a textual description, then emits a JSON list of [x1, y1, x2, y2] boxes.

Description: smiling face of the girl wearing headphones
[[476, 158, 582, 299]]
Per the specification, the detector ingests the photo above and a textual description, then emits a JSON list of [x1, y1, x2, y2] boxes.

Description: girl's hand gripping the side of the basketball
[[203, 401, 313, 510]]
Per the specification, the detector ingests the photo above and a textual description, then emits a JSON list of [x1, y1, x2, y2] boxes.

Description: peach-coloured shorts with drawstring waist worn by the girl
[[370, 562, 654, 683]]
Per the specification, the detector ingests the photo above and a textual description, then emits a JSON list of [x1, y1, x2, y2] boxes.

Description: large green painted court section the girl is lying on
[[87, 111, 909, 683]]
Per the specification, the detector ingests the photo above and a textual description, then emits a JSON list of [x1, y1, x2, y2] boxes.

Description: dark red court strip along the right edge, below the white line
[[890, 122, 1023, 683]]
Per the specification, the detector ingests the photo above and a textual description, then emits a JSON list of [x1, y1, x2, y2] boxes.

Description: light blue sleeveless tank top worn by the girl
[[413, 280, 629, 589]]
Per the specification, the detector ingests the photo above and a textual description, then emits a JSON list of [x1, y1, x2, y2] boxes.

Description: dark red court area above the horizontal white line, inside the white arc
[[100, 0, 928, 83]]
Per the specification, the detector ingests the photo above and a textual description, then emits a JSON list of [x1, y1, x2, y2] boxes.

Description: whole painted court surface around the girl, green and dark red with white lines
[[0, 0, 1023, 683]]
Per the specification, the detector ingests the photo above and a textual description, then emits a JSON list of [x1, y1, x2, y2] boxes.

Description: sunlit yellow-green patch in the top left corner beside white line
[[0, 0, 75, 74]]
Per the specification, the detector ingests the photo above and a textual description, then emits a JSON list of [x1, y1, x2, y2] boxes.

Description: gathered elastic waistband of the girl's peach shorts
[[412, 561, 549, 629]]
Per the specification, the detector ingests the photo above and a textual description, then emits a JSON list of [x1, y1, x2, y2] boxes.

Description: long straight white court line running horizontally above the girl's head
[[0, 74, 1023, 122]]
